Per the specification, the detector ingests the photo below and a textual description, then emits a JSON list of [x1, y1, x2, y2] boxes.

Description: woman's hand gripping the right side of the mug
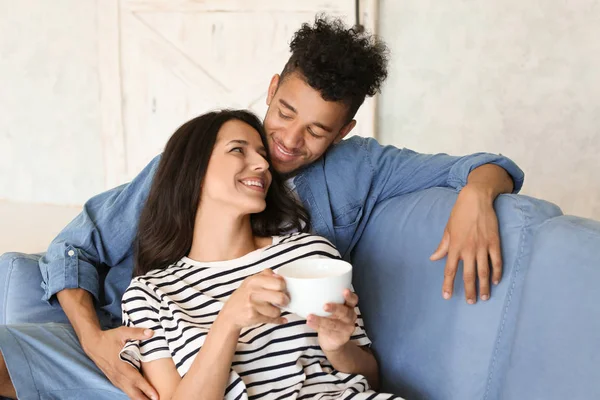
[[307, 289, 358, 353]]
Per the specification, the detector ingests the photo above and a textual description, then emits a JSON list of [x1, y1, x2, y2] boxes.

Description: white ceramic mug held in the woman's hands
[[276, 258, 352, 318]]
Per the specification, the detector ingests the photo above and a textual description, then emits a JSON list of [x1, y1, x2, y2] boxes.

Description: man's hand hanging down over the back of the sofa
[[431, 184, 502, 304]]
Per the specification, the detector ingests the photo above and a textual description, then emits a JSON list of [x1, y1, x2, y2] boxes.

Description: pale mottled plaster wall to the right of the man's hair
[[379, 0, 600, 219]]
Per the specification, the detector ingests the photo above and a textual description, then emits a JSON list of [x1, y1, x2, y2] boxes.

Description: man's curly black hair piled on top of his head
[[281, 15, 389, 121]]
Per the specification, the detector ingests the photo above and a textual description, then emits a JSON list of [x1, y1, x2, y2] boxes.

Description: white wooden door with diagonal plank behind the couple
[[98, 0, 375, 187]]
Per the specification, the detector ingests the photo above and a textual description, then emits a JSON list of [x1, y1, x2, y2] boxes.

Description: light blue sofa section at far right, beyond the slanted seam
[[501, 216, 600, 400]]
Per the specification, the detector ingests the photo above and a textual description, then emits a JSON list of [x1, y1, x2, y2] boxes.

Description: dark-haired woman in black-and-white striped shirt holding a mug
[[121, 111, 393, 400]]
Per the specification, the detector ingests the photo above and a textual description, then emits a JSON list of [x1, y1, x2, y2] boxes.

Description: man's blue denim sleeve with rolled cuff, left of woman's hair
[[39, 156, 160, 302]]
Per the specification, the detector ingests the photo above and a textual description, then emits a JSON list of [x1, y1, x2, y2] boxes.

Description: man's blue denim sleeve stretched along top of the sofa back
[[363, 139, 525, 201]]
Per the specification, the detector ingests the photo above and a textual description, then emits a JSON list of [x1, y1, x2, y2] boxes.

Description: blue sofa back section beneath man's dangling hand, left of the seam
[[353, 188, 561, 400]]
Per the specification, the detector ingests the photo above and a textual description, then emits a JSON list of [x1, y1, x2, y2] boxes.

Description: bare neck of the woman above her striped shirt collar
[[189, 207, 269, 262]]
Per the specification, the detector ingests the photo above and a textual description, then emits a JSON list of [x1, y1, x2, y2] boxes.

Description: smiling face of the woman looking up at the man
[[200, 120, 271, 215]]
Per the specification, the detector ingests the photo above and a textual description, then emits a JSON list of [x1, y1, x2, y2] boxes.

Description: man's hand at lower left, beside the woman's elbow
[[82, 326, 158, 400]]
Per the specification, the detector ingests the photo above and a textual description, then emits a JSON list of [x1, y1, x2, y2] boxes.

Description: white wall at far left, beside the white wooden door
[[0, 0, 104, 204]]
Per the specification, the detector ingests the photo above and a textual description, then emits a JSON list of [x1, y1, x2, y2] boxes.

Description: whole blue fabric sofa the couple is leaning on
[[0, 188, 600, 400]]
